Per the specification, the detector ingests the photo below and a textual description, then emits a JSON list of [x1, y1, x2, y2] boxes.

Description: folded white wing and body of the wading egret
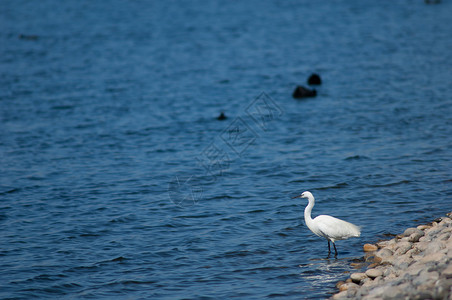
[[314, 215, 361, 242]]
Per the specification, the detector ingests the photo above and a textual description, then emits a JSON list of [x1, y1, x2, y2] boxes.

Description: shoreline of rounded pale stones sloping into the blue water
[[331, 212, 452, 300]]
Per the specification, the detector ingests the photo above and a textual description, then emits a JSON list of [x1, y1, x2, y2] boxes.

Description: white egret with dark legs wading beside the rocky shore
[[293, 191, 361, 256]]
